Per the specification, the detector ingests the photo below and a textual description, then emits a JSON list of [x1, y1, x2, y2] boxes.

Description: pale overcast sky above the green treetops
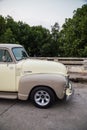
[[0, 0, 87, 29]]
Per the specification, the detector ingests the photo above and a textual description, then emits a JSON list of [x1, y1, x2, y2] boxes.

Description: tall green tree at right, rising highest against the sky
[[60, 5, 87, 57]]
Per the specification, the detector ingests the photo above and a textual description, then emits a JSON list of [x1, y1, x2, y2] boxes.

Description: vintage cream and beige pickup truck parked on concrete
[[0, 44, 72, 108]]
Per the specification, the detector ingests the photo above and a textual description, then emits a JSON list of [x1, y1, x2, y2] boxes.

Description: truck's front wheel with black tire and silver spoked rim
[[31, 87, 55, 108]]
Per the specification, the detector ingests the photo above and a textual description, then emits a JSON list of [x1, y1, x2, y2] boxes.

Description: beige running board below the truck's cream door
[[0, 92, 18, 99]]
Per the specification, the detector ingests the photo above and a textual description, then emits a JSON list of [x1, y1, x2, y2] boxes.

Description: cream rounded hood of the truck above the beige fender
[[22, 59, 67, 76]]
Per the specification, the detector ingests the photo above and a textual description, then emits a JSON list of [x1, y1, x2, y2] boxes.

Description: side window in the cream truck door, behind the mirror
[[0, 49, 12, 62]]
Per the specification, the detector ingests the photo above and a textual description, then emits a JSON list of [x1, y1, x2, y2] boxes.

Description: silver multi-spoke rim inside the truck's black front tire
[[34, 90, 50, 106]]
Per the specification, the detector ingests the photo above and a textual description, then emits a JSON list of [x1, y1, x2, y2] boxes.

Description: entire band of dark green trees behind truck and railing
[[0, 5, 87, 57]]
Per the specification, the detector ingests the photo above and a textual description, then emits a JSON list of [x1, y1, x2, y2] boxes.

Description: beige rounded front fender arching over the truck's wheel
[[18, 74, 66, 100]]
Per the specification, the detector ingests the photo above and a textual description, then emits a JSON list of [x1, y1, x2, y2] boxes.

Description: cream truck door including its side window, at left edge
[[0, 49, 16, 92]]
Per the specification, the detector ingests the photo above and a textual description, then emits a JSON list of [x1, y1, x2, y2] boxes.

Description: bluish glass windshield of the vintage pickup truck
[[12, 47, 28, 61]]
